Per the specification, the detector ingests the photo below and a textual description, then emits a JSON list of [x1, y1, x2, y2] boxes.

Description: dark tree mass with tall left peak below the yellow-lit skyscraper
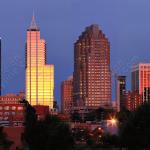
[[23, 101, 73, 150]]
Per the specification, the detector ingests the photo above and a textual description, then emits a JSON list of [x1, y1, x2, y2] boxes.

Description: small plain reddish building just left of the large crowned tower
[[61, 77, 73, 114]]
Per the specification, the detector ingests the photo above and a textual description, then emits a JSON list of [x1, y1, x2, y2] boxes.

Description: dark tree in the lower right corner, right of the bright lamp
[[120, 103, 150, 150]]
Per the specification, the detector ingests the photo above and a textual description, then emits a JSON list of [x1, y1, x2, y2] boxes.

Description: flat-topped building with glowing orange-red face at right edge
[[131, 63, 150, 102]]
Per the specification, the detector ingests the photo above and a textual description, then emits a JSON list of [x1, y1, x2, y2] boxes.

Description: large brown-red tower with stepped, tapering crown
[[73, 25, 111, 109]]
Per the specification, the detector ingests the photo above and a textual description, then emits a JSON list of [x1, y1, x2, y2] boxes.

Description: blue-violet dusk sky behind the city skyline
[[0, 0, 150, 105]]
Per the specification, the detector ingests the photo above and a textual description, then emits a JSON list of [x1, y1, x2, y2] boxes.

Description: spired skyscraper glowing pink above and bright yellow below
[[26, 16, 54, 108]]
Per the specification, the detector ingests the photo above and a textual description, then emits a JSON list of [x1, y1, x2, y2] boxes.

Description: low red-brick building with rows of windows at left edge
[[0, 92, 25, 126]]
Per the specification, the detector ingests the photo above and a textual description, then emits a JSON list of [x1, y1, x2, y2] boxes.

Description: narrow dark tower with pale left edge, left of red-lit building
[[116, 76, 126, 112]]
